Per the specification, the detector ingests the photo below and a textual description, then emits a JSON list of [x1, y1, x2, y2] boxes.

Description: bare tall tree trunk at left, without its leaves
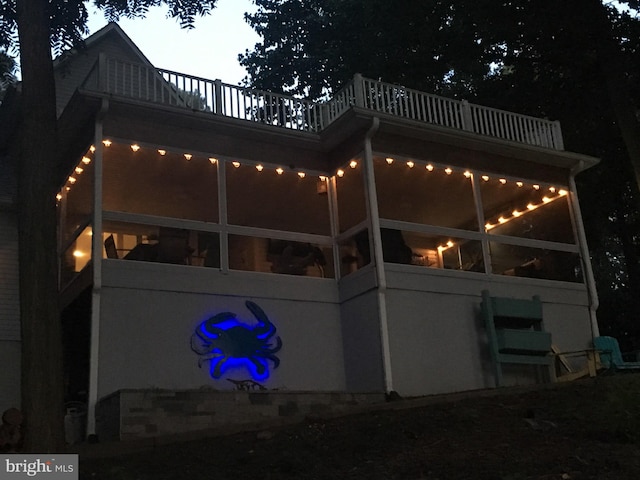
[[16, 0, 64, 453]]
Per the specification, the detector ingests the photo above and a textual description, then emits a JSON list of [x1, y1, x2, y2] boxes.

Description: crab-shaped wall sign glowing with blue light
[[191, 301, 282, 380]]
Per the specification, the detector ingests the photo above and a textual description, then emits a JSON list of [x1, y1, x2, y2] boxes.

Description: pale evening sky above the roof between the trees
[[87, 0, 260, 85]]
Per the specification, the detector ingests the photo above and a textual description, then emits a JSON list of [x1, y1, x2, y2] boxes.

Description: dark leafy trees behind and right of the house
[[240, 0, 640, 348]]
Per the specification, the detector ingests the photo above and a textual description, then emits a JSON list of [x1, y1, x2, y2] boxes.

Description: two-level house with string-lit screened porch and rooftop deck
[[0, 24, 597, 440]]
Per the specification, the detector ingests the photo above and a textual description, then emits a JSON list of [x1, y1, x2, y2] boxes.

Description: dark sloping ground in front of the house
[[80, 373, 640, 480]]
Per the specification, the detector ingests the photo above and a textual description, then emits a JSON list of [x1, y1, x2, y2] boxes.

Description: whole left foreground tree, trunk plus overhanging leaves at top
[[0, 0, 217, 453]]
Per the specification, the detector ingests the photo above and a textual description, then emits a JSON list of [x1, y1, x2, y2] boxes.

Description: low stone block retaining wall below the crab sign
[[96, 390, 385, 441]]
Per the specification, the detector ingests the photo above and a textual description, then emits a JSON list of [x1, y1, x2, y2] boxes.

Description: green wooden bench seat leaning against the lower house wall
[[482, 290, 554, 387]]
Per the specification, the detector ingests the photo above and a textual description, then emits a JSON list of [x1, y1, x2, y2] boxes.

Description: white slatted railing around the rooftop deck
[[85, 57, 564, 150]]
